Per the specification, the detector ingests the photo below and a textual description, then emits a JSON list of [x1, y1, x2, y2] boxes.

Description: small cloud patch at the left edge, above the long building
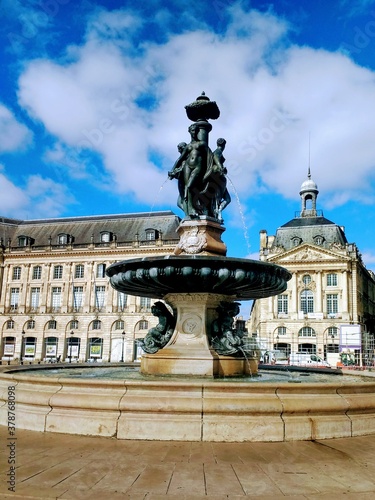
[[0, 103, 32, 152]]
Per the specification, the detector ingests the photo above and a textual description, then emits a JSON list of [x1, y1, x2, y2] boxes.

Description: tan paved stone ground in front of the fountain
[[0, 427, 375, 500]]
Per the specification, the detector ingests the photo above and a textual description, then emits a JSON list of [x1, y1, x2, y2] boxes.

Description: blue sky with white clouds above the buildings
[[0, 0, 375, 269]]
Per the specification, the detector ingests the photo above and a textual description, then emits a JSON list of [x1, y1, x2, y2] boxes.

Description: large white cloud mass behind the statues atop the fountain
[[19, 5, 375, 206]]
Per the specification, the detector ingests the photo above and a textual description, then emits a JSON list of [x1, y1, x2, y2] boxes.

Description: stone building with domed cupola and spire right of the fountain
[[249, 170, 375, 365]]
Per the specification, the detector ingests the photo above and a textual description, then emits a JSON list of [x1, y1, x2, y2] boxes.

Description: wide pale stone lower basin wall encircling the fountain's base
[[0, 365, 375, 442]]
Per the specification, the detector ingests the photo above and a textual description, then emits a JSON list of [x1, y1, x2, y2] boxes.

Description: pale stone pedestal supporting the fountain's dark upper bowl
[[141, 293, 258, 378]]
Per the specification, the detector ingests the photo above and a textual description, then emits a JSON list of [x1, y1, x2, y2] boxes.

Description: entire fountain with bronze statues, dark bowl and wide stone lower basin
[[0, 95, 375, 441]]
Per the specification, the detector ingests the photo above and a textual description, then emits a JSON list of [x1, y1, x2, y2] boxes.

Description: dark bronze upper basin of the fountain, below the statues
[[107, 255, 291, 300]]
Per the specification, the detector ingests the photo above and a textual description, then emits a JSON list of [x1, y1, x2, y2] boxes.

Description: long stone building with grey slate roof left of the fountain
[[0, 211, 180, 362]]
